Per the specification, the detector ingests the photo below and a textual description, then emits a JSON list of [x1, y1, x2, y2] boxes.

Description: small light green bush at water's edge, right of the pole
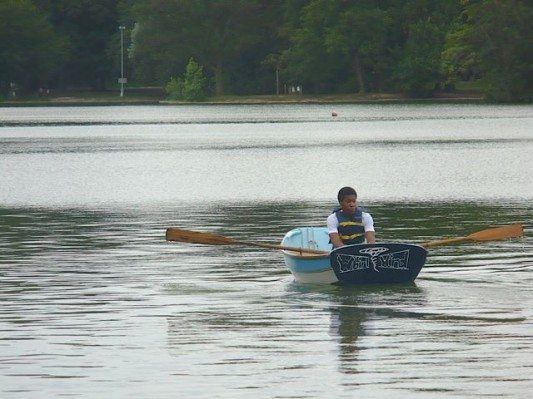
[[165, 58, 207, 101]]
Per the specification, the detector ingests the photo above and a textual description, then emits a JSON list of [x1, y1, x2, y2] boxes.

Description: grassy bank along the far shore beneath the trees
[[0, 87, 483, 107]]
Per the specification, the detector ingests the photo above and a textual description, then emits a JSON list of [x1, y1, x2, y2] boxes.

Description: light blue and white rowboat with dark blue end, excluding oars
[[281, 227, 427, 284]]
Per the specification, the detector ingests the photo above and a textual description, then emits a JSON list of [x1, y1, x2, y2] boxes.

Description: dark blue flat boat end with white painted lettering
[[330, 243, 427, 284]]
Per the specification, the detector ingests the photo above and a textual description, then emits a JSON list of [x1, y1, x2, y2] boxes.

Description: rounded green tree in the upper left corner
[[0, 0, 66, 94]]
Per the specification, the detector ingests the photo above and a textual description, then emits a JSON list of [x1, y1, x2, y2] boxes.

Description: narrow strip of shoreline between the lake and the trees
[[0, 92, 486, 108]]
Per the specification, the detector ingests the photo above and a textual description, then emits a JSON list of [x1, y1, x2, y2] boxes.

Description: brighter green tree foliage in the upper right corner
[[444, 0, 533, 102]]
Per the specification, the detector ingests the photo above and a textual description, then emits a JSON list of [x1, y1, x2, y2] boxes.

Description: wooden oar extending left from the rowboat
[[166, 228, 329, 255]]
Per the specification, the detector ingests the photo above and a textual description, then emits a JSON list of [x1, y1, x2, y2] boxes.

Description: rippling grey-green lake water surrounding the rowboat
[[0, 104, 533, 398]]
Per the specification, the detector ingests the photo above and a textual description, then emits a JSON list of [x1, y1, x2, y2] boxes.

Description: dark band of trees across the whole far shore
[[0, 0, 533, 101]]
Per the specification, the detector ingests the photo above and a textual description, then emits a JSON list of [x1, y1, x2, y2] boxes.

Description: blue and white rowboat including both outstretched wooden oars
[[165, 224, 524, 284]]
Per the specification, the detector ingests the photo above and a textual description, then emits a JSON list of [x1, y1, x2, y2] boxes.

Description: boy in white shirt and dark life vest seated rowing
[[327, 187, 376, 248]]
